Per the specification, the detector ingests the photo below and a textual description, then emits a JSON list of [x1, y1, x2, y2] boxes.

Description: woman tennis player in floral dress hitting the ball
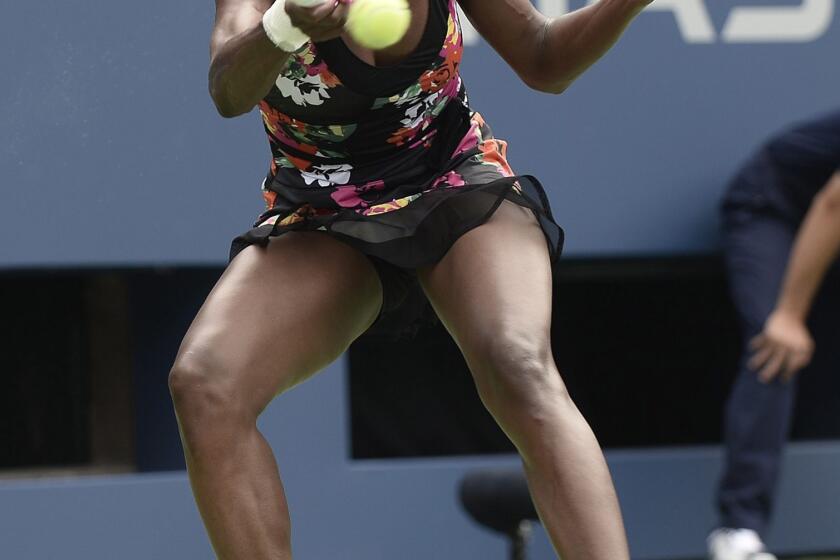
[[170, 0, 646, 560]]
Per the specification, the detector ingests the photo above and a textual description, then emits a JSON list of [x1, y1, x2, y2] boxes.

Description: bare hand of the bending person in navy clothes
[[749, 311, 814, 383]]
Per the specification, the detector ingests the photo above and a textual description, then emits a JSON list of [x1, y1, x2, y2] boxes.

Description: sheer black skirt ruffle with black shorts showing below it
[[230, 175, 564, 340]]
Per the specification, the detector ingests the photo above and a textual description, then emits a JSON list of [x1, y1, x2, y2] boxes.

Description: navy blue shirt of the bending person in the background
[[724, 111, 840, 222]]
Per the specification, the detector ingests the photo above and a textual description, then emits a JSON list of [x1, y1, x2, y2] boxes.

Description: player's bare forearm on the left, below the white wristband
[[209, 23, 289, 117]]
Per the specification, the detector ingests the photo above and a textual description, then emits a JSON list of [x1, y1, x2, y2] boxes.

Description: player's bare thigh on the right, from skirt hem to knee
[[419, 201, 552, 374]]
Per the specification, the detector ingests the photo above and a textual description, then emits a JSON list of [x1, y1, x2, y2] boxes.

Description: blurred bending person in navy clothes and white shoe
[[708, 111, 840, 560]]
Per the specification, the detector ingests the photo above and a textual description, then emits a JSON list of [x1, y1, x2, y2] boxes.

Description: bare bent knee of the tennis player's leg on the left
[[169, 353, 247, 435]]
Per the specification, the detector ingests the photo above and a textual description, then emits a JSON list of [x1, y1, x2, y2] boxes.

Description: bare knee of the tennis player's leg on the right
[[478, 331, 568, 414]]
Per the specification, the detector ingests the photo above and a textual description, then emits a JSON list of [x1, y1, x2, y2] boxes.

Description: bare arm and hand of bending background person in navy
[[750, 171, 840, 383]]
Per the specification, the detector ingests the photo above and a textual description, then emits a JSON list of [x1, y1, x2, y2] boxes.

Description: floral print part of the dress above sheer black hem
[[258, 0, 513, 227]]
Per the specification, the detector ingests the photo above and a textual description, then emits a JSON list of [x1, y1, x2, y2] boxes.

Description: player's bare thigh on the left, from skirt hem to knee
[[173, 232, 382, 409]]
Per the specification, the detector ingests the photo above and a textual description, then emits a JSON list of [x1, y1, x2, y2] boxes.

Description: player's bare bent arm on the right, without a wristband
[[459, 0, 650, 93]]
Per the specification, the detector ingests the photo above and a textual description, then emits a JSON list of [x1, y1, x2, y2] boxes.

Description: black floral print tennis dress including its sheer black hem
[[231, 0, 563, 268]]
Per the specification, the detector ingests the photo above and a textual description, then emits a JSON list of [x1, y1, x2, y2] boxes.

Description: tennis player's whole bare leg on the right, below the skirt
[[419, 201, 629, 560]]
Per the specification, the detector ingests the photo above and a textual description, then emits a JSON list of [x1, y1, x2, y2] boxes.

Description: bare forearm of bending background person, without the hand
[[776, 173, 840, 321]]
